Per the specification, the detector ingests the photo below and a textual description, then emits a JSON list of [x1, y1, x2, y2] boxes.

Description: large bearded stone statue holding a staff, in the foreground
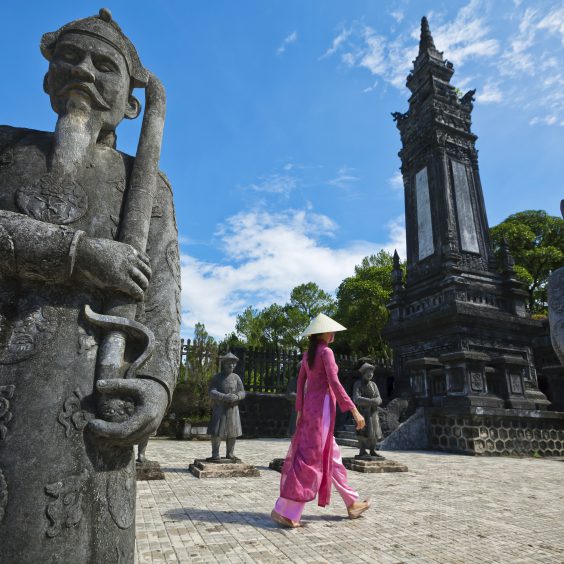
[[0, 10, 180, 564]]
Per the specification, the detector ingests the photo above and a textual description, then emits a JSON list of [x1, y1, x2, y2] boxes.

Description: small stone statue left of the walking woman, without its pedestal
[[208, 353, 245, 462]]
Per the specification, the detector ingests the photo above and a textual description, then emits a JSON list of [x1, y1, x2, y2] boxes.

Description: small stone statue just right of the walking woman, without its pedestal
[[352, 362, 382, 458]]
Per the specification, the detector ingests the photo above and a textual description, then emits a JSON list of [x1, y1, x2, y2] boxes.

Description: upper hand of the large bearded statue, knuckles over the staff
[[75, 235, 151, 300]]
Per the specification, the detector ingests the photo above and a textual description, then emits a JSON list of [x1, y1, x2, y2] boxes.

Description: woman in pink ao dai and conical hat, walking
[[271, 313, 370, 528]]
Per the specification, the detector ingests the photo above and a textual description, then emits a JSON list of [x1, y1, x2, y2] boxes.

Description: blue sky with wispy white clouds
[[0, 0, 564, 337]]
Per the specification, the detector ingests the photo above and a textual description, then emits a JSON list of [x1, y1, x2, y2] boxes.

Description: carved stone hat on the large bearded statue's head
[[41, 8, 149, 88]]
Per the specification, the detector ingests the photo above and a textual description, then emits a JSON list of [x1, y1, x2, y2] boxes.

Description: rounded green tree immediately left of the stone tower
[[335, 250, 393, 356]]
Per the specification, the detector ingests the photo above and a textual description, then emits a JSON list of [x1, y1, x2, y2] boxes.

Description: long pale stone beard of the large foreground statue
[[51, 93, 97, 177]]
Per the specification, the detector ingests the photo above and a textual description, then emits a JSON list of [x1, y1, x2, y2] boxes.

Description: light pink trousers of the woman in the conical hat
[[274, 394, 358, 521]]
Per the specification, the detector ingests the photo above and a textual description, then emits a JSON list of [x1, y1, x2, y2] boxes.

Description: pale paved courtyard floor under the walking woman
[[137, 439, 564, 564]]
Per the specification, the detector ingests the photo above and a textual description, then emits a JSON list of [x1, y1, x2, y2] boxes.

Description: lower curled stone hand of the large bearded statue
[[88, 378, 168, 446]]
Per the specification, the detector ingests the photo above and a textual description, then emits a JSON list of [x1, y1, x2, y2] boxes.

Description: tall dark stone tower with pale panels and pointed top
[[385, 18, 560, 458]]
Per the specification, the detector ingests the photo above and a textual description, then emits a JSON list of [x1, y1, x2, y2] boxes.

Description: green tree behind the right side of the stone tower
[[490, 210, 564, 314]]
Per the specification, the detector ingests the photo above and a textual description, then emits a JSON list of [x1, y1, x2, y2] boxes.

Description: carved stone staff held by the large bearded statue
[[85, 73, 166, 412]]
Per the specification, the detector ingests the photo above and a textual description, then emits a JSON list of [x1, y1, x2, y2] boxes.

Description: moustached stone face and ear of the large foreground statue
[[45, 33, 138, 131]]
